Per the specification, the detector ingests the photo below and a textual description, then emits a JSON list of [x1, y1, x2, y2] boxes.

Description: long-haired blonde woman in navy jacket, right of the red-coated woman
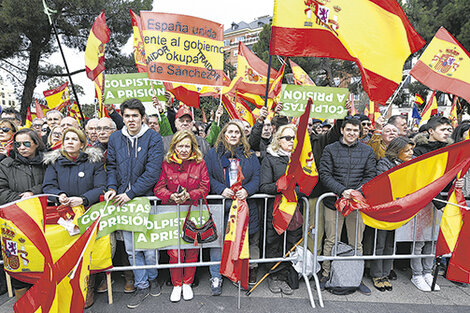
[[204, 121, 260, 296]]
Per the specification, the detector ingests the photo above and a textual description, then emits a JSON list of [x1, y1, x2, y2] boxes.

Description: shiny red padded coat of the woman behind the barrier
[[154, 160, 210, 204]]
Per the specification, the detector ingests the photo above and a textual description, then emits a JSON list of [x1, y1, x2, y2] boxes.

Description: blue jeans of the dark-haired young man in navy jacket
[[122, 231, 158, 289]]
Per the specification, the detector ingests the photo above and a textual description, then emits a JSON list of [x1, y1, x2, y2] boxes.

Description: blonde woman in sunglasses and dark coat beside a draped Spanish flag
[[259, 124, 302, 295]]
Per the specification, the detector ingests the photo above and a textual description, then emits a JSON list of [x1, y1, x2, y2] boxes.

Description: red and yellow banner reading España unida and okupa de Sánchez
[[140, 11, 224, 86]]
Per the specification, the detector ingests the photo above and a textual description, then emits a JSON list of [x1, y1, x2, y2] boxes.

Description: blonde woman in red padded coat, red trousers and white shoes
[[154, 130, 210, 302]]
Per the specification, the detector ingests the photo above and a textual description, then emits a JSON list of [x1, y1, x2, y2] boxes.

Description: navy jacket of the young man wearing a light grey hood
[[106, 124, 163, 199]]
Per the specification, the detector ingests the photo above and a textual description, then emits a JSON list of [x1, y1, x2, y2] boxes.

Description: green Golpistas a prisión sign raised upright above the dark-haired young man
[[104, 73, 167, 104]]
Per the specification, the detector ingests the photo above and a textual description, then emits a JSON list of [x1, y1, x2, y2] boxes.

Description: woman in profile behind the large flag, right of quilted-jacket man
[[370, 136, 414, 291]]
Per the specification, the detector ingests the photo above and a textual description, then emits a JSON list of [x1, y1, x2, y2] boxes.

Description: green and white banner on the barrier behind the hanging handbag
[[134, 204, 224, 249]]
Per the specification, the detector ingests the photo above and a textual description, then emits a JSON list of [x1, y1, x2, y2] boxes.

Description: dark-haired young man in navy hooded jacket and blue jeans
[[104, 99, 163, 309]]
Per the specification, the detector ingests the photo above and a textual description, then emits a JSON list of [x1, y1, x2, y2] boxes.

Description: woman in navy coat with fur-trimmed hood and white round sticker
[[43, 127, 106, 308]]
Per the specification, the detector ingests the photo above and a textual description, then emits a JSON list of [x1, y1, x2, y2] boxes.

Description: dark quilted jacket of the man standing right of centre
[[318, 138, 377, 209]]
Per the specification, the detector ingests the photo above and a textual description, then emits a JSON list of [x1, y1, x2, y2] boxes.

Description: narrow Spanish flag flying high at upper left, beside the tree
[[85, 10, 111, 81]]
